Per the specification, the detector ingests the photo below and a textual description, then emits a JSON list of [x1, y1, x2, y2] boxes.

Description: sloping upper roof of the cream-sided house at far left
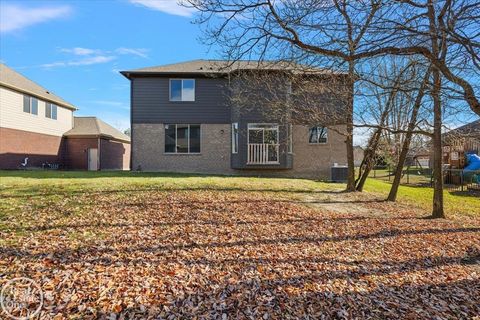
[[0, 63, 77, 110]]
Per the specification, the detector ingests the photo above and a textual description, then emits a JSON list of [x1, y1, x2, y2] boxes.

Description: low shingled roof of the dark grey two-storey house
[[120, 59, 342, 78]]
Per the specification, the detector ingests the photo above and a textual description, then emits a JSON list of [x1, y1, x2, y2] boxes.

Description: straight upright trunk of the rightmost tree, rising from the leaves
[[432, 68, 445, 218]]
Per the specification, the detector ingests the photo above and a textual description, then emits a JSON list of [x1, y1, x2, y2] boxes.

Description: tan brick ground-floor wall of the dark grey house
[[132, 124, 347, 179]]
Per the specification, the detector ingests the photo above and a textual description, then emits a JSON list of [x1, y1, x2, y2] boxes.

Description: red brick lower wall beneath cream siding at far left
[[0, 128, 63, 169]]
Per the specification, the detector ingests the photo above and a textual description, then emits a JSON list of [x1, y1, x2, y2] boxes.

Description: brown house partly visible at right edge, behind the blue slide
[[443, 120, 480, 169]]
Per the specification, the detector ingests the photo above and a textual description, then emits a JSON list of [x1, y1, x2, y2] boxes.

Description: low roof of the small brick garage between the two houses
[[64, 117, 130, 143]]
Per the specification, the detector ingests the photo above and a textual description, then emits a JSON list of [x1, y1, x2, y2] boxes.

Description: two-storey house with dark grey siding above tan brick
[[121, 60, 346, 179]]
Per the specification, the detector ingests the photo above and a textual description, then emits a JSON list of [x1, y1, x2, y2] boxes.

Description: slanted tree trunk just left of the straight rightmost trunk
[[387, 70, 430, 201]]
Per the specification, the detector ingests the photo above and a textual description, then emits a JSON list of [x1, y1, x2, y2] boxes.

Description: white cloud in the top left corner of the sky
[[0, 2, 72, 33]]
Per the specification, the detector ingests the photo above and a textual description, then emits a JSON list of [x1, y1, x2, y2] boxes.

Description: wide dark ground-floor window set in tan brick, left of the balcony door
[[165, 124, 200, 153]]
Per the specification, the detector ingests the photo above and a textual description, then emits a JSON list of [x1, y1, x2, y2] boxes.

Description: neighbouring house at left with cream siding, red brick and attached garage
[[0, 64, 130, 170]]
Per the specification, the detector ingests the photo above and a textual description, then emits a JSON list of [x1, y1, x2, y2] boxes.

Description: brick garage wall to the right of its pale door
[[100, 139, 130, 170]]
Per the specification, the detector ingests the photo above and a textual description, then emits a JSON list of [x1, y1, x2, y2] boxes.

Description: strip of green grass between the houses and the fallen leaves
[[0, 171, 480, 222]]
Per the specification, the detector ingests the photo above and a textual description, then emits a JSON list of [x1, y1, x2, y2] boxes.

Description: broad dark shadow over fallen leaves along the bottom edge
[[91, 278, 480, 319]]
